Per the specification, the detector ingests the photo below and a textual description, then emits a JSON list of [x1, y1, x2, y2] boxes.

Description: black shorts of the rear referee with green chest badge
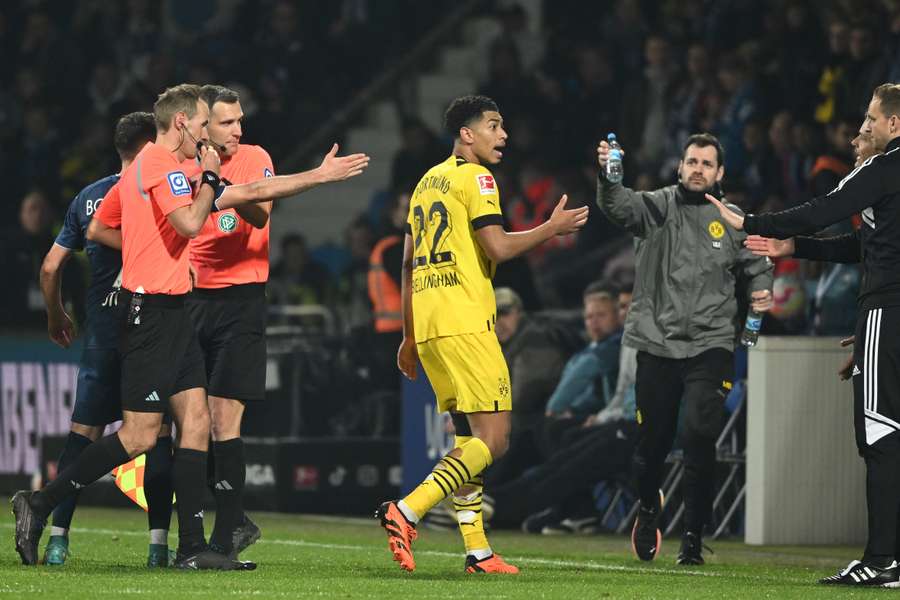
[[187, 283, 267, 402]]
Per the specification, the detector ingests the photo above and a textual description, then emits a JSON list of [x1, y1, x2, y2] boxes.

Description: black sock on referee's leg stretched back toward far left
[[31, 433, 129, 518]]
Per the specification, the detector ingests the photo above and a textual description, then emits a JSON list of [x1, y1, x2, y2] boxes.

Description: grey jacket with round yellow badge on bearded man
[[597, 175, 772, 359]]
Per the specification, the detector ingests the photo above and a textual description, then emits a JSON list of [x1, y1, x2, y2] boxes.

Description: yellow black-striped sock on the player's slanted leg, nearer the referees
[[401, 437, 493, 521]]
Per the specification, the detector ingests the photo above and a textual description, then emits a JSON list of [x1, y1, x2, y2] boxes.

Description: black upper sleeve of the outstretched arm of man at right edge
[[744, 156, 887, 240]]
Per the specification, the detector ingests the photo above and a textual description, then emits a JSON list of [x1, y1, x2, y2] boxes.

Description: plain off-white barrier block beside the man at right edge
[[746, 337, 866, 544]]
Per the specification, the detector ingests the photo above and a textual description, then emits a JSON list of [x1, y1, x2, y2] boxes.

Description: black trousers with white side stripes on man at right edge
[[853, 306, 900, 565]]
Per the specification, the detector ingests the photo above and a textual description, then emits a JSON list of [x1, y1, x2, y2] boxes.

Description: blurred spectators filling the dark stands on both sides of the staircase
[[0, 0, 884, 464]]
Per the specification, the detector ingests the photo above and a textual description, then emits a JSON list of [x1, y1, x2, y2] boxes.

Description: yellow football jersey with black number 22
[[407, 156, 503, 342]]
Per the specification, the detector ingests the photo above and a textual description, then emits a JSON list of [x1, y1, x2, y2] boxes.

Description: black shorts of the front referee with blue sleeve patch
[[119, 289, 206, 413]]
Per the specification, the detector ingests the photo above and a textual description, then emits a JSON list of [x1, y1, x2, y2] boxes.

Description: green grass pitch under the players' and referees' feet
[[0, 498, 884, 600]]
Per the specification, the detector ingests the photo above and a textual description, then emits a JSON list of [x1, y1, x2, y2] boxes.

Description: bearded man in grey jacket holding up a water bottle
[[597, 134, 772, 564]]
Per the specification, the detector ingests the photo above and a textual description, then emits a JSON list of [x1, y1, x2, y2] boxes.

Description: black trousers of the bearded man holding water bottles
[[633, 348, 734, 534]]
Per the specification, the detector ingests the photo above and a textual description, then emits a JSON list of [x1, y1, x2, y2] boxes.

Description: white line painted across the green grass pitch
[[0, 523, 813, 584]]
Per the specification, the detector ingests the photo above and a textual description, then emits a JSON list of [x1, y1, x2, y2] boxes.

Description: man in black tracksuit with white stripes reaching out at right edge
[[707, 84, 900, 587]]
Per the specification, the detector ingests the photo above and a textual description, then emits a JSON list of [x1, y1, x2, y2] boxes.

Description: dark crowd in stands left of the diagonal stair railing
[[0, 0, 451, 329]]
